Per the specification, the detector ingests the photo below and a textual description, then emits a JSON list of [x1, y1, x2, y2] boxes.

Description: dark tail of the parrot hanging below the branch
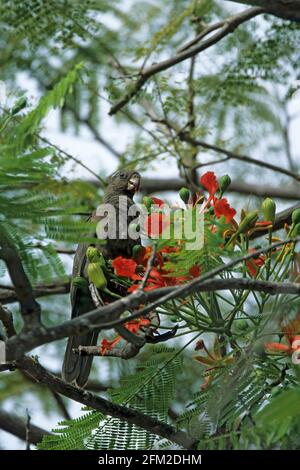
[[62, 331, 99, 388]]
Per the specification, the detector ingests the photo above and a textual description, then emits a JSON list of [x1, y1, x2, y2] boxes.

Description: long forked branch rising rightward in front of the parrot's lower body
[[6, 237, 300, 362]]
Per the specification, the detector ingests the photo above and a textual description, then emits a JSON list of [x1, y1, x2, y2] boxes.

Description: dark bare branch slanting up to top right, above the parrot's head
[[109, 8, 265, 116]]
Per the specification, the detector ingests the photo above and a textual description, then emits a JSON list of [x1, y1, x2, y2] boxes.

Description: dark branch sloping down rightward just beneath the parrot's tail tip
[[17, 357, 196, 449]]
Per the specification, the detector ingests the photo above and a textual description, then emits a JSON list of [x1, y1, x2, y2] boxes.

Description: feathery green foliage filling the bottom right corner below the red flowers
[[178, 355, 298, 450]]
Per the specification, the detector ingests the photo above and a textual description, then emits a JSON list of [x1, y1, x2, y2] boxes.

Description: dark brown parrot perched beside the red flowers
[[62, 170, 140, 387]]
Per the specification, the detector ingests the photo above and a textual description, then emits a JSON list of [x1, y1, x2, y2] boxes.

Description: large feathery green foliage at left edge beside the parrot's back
[[0, 64, 91, 282]]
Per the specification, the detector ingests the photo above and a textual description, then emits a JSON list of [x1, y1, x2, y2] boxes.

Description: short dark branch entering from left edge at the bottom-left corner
[[0, 409, 50, 444]]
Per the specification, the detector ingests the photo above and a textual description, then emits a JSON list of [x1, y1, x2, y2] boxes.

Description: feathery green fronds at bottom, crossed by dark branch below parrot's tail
[[38, 348, 182, 450]]
